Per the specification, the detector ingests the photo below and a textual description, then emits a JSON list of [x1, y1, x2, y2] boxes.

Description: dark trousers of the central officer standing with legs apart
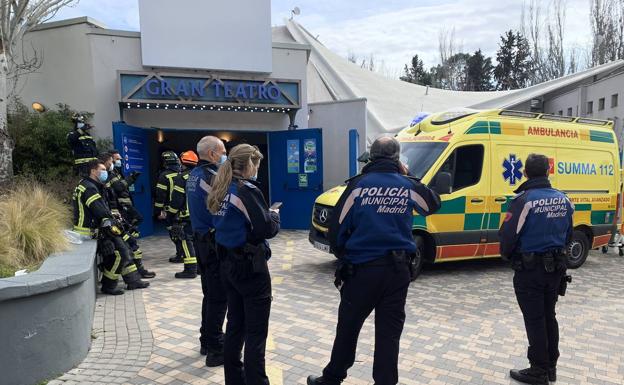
[[323, 264, 410, 385]]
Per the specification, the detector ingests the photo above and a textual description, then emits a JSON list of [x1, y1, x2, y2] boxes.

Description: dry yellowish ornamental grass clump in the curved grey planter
[[0, 182, 70, 276]]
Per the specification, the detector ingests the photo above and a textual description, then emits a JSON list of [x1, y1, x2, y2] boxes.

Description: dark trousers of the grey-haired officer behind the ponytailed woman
[[194, 233, 227, 352]]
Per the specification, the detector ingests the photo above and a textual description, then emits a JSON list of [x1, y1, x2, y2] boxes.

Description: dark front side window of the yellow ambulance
[[438, 144, 483, 191]]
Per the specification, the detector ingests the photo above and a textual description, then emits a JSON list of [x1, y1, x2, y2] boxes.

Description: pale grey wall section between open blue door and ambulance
[[308, 99, 366, 190]]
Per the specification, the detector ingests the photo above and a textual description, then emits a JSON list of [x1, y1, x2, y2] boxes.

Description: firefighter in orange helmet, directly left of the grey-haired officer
[[166, 151, 199, 278]]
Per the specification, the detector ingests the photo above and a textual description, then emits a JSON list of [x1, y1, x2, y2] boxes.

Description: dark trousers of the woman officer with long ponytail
[[221, 255, 272, 385]]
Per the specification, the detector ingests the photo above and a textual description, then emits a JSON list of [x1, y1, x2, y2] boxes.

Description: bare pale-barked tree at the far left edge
[[0, 0, 78, 183]]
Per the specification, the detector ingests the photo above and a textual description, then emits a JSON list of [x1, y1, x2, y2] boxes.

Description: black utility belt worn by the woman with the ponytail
[[223, 243, 270, 280]]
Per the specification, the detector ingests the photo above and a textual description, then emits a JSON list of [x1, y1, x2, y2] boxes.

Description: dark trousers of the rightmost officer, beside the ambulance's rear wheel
[[513, 266, 565, 369]]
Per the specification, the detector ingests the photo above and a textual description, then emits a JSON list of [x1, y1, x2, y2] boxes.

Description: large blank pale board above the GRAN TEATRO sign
[[139, 0, 272, 73]]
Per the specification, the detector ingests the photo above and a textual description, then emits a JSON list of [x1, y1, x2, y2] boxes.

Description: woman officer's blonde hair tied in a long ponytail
[[207, 144, 264, 214]]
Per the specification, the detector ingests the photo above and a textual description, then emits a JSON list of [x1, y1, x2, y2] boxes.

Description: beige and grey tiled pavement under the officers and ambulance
[[50, 232, 624, 385]]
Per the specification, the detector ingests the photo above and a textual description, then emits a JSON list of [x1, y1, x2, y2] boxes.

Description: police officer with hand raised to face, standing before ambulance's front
[[308, 137, 440, 385]]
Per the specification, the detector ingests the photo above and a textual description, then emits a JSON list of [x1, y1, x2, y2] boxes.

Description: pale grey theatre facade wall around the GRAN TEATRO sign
[[17, 22, 309, 137]]
